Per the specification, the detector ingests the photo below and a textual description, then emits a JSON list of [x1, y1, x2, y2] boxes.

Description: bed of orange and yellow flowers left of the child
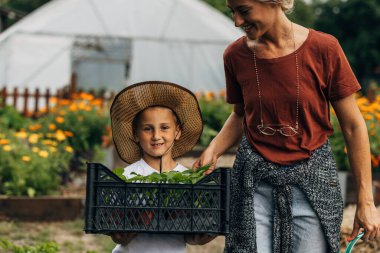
[[0, 93, 108, 197]]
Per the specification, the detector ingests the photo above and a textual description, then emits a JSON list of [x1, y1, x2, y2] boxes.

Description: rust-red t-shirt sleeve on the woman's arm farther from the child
[[328, 38, 361, 101]]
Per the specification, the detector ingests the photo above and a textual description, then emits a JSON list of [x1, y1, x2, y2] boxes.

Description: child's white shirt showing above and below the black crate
[[112, 159, 187, 253]]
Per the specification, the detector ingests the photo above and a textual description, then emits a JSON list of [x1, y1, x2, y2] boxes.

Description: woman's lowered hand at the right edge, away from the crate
[[347, 202, 380, 241]]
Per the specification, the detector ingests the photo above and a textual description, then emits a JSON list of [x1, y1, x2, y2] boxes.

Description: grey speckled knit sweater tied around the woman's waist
[[225, 137, 343, 253]]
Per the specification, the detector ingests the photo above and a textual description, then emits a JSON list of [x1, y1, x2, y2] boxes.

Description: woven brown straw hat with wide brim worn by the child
[[110, 81, 203, 164]]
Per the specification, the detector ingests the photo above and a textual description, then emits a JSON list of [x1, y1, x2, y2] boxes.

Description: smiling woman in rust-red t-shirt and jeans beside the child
[[194, 0, 380, 253]]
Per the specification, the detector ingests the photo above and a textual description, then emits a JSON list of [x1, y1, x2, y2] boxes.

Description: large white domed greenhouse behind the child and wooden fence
[[0, 0, 242, 91]]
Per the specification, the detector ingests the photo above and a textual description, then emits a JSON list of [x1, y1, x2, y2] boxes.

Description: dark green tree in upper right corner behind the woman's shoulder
[[315, 0, 380, 86]]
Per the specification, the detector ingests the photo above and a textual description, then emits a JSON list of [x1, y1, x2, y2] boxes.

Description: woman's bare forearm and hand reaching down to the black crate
[[193, 104, 244, 174]]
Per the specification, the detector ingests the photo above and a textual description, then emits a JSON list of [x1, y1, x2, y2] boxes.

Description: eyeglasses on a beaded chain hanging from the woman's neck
[[252, 22, 300, 136]]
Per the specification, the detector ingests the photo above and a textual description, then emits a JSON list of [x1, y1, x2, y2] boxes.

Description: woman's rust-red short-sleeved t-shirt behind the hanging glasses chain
[[224, 29, 360, 165]]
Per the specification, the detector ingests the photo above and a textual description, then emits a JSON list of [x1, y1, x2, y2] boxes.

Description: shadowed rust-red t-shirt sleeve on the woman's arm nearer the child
[[224, 54, 243, 104]]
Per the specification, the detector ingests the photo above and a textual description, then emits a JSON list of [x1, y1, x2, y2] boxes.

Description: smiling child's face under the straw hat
[[135, 107, 181, 157]]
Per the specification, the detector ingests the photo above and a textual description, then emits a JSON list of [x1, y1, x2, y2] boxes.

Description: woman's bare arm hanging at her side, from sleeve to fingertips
[[331, 95, 380, 240]]
